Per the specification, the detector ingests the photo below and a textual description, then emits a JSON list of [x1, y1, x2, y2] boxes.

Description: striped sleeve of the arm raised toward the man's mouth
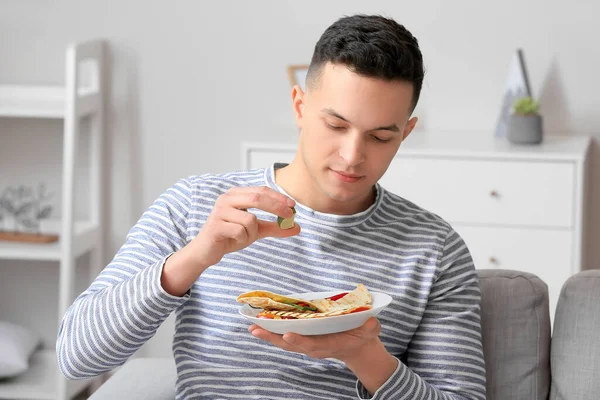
[[56, 179, 192, 379]]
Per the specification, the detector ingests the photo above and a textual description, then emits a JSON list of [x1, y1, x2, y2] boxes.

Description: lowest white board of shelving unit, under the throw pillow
[[0, 350, 92, 400]]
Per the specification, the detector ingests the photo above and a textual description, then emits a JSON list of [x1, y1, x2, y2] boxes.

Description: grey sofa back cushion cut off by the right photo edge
[[550, 270, 600, 400]]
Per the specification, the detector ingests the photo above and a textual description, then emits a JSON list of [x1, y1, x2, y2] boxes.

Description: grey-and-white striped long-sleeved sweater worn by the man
[[56, 165, 485, 400]]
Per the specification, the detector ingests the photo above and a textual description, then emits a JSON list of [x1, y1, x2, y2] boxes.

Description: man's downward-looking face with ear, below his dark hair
[[293, 63, 417, 209]]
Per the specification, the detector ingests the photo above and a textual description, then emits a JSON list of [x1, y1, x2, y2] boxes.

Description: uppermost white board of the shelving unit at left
[[0, 85, 65, 119]]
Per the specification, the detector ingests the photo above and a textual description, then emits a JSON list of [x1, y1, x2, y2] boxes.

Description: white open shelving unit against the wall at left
[[0, 40, 104, 400]]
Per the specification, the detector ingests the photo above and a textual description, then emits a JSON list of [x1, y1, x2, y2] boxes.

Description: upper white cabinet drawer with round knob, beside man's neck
[[381, 156, 575, 228]]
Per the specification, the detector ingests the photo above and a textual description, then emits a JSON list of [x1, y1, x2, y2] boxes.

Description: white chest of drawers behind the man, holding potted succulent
[[242, 132, 590, 319]]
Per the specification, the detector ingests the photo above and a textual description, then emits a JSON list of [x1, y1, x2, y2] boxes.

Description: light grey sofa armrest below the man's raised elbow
[[89, 358, 177, 400]]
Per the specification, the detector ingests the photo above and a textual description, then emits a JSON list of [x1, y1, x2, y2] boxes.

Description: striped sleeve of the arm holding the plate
[[356, 230, 486, 400]]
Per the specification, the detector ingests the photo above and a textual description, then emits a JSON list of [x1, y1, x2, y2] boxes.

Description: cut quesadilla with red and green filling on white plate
[[237, 284, 372, 319]]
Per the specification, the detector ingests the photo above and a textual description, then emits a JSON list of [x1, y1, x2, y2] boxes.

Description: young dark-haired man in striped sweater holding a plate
[[57, 15, 485, 400]]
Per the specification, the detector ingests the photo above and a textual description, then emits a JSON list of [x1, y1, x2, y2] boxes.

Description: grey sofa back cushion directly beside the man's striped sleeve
[[477, 269, 550, 400]]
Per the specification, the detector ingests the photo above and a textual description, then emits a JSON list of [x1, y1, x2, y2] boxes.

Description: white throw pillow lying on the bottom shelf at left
[[0, 321, 41, 378]]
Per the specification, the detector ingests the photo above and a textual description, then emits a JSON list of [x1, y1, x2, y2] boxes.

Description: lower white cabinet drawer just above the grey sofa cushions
[[453, 224, 573, 315]]
